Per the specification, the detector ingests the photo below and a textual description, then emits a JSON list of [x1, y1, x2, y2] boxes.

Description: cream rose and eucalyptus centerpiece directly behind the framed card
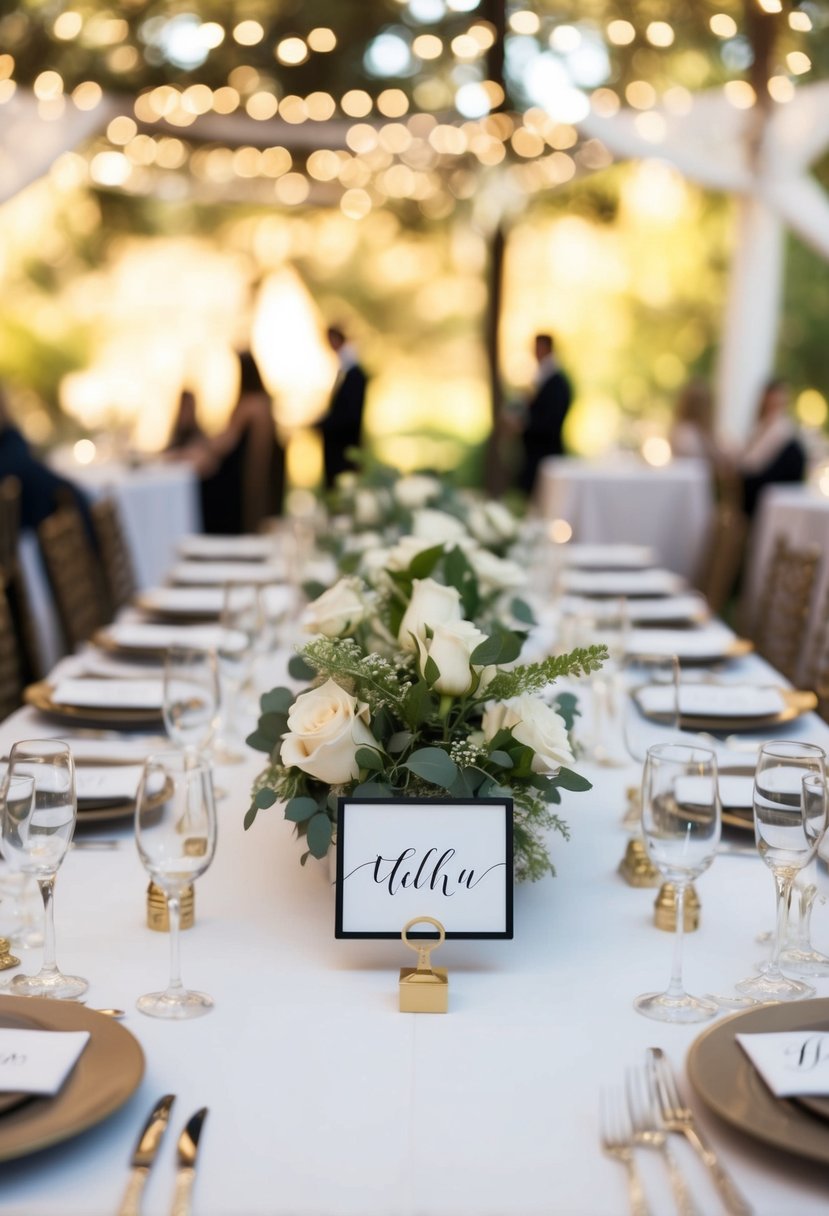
[[246, 547, 607, 879]]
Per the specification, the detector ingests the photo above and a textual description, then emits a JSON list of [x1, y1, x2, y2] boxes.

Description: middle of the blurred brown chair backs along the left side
[[38, 506, 112, 649]]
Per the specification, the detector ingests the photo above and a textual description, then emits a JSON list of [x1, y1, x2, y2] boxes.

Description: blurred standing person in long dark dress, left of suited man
[[195, 350, 284, 536]]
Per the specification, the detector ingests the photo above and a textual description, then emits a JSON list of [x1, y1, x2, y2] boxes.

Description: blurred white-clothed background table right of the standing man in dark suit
[[537, 456, 712, 580]]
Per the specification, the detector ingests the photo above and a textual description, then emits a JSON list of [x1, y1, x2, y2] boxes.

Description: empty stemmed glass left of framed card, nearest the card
[[135, 748, 216, 1019]]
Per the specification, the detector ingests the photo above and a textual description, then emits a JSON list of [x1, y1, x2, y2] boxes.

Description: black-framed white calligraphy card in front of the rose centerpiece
[[335, 798, 513, 939]]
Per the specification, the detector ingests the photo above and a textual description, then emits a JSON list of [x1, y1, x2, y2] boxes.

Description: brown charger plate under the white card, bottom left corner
[[0, 996, 143, 1161]]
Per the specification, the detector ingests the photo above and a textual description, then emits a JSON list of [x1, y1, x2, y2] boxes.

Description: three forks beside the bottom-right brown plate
[[599, 1047, 751, 1216]]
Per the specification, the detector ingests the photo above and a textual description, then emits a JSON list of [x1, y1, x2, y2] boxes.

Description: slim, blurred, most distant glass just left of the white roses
[[213, 582, 265, 764]]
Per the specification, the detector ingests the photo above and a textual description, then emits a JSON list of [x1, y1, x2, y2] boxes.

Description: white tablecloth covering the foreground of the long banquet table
[[0, 657, 829, 1216]]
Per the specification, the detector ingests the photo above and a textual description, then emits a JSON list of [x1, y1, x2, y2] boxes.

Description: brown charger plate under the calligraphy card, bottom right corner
[[688, 997, 829, 1165]]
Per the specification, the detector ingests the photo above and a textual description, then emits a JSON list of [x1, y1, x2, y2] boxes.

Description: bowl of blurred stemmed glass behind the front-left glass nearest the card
[[163, 646, 219, 750]]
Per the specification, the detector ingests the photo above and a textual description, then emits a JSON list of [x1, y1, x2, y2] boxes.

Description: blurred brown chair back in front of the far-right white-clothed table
[[752, 536, 820, 683]]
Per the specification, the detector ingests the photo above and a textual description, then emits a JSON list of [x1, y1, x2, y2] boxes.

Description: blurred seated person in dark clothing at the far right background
[[737, 379, 806, 516]]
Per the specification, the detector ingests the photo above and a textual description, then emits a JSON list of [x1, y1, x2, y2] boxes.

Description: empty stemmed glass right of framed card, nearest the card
[[633, 743, 721, 1023]]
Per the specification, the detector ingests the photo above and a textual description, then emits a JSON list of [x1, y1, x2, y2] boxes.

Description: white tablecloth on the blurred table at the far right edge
[[743, 485, 829, 680]]
